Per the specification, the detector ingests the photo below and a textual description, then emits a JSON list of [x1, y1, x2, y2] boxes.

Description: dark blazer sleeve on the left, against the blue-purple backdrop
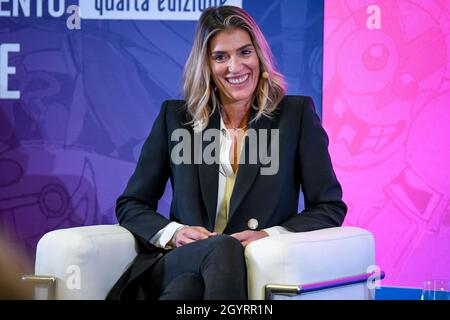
[[116, 101, 170, 245]]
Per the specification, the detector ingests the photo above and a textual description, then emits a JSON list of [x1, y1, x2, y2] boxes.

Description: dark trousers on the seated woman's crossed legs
[[145, 235, 247, 300]]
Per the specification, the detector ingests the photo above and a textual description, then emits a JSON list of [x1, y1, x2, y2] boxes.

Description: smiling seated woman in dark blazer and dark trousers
[[109, 6, 347, 299]]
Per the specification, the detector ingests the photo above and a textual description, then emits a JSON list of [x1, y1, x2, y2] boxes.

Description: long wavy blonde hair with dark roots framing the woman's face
[[183, 6, 286, 131]]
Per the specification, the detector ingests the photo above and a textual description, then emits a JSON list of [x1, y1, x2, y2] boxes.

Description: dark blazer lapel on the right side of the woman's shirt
[[228, 109, 272, 219]]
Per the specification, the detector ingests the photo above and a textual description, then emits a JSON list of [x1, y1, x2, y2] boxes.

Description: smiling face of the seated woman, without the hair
[[209, 29, 259, 105]]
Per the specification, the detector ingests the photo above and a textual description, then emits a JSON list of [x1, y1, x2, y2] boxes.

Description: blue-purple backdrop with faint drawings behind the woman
[[0, 0, 323, 254]]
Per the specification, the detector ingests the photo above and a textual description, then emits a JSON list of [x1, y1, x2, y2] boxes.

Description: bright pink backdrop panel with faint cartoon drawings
[[323, 0, 450, 287]]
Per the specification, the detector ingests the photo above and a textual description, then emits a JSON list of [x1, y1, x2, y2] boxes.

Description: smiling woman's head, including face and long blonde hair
[[184, 6, 286, 130]]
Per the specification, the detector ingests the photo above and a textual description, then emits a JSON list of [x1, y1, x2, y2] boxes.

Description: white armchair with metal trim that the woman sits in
[[23, 225, 375, 299]]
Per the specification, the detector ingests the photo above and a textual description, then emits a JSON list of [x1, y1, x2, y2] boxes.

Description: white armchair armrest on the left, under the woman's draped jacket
[[31, 225, 137, 299]]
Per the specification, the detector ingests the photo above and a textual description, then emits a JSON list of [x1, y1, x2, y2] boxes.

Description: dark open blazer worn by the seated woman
[[110, 96, 347, 298]]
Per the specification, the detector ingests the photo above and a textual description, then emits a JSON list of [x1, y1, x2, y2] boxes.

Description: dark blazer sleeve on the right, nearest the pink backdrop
[[281, 97, 347, 232]]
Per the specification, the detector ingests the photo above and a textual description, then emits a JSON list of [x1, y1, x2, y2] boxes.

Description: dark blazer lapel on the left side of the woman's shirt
[[198, 109, 220, 230]]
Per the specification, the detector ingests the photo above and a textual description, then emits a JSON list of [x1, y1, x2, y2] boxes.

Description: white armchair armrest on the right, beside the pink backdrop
[[245, 227, 375, 299]]
